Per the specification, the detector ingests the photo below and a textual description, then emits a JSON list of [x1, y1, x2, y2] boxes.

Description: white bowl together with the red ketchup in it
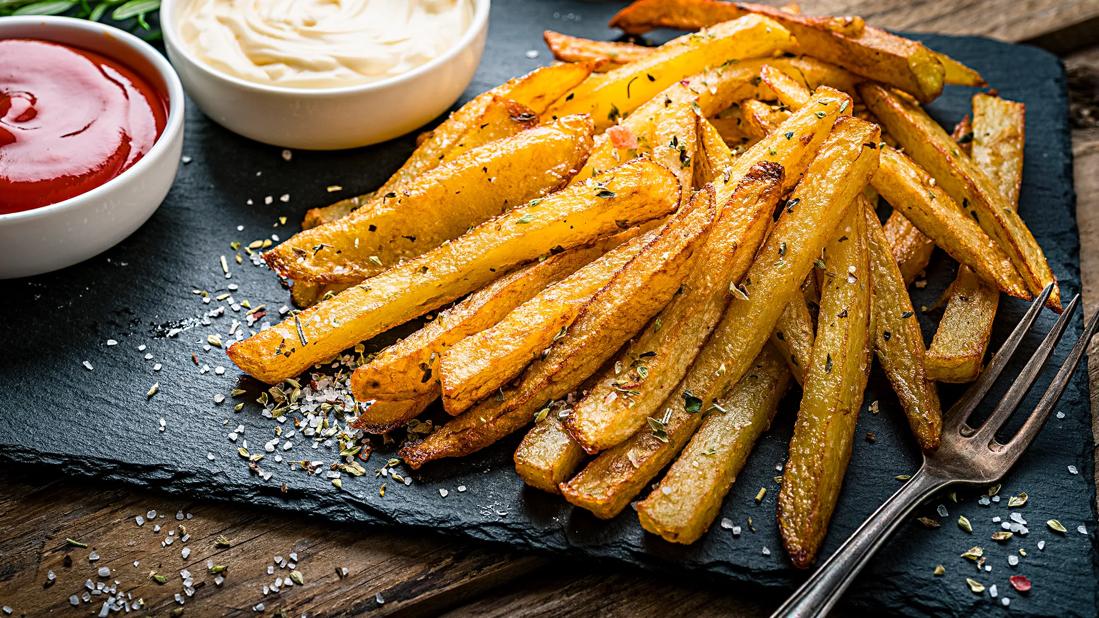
[[0, 16, 184, 278]]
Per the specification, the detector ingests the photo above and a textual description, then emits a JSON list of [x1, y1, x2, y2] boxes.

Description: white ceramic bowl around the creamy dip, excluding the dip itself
[[160, 0, 490, 150]]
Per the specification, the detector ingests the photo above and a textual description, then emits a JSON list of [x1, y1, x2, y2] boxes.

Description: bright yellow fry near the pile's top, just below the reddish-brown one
[[546, 15, 792, 131]]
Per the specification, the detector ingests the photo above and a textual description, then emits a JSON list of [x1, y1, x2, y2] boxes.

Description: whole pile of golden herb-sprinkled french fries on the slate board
[[229, 0, 1059, 566]]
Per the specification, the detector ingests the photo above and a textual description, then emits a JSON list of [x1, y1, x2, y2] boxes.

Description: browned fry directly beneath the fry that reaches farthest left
[[351, 233, 636, 433]]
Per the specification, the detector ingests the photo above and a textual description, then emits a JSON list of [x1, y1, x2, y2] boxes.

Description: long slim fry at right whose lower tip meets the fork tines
[[859, 84, 1061, 311]]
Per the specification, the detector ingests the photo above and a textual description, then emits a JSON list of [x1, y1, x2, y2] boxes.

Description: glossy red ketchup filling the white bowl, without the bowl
[[0, 38, 168, 213]]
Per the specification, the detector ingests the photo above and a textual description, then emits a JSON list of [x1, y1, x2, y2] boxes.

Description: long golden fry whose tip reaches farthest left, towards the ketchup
[[229, 159, 679, 384]]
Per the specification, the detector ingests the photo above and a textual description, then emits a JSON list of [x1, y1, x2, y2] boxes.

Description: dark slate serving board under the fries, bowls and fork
[[0, 0, 1097, 616]]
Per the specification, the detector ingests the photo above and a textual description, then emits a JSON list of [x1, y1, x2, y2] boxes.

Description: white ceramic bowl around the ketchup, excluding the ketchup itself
[[0, 16, 184, 279]]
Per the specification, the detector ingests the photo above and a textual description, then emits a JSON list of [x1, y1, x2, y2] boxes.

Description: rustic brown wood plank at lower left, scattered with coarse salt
[[0, 471, 543, 616]]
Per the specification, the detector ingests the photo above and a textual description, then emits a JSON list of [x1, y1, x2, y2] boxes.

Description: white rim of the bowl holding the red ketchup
[[0, 15, 186, 224]]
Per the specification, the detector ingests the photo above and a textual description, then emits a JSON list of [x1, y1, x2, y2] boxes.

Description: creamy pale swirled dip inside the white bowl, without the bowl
[[178, 0, 473, 88]]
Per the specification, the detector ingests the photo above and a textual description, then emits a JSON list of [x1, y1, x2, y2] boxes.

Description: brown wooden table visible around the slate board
[[0, 0, 1099, 616]]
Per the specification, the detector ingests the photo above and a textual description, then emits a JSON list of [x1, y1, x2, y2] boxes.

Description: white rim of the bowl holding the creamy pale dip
[[160, 0, 492, 98]]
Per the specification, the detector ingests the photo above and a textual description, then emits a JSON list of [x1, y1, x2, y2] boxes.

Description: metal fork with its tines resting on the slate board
[[771, 286, 1099, 618]]
